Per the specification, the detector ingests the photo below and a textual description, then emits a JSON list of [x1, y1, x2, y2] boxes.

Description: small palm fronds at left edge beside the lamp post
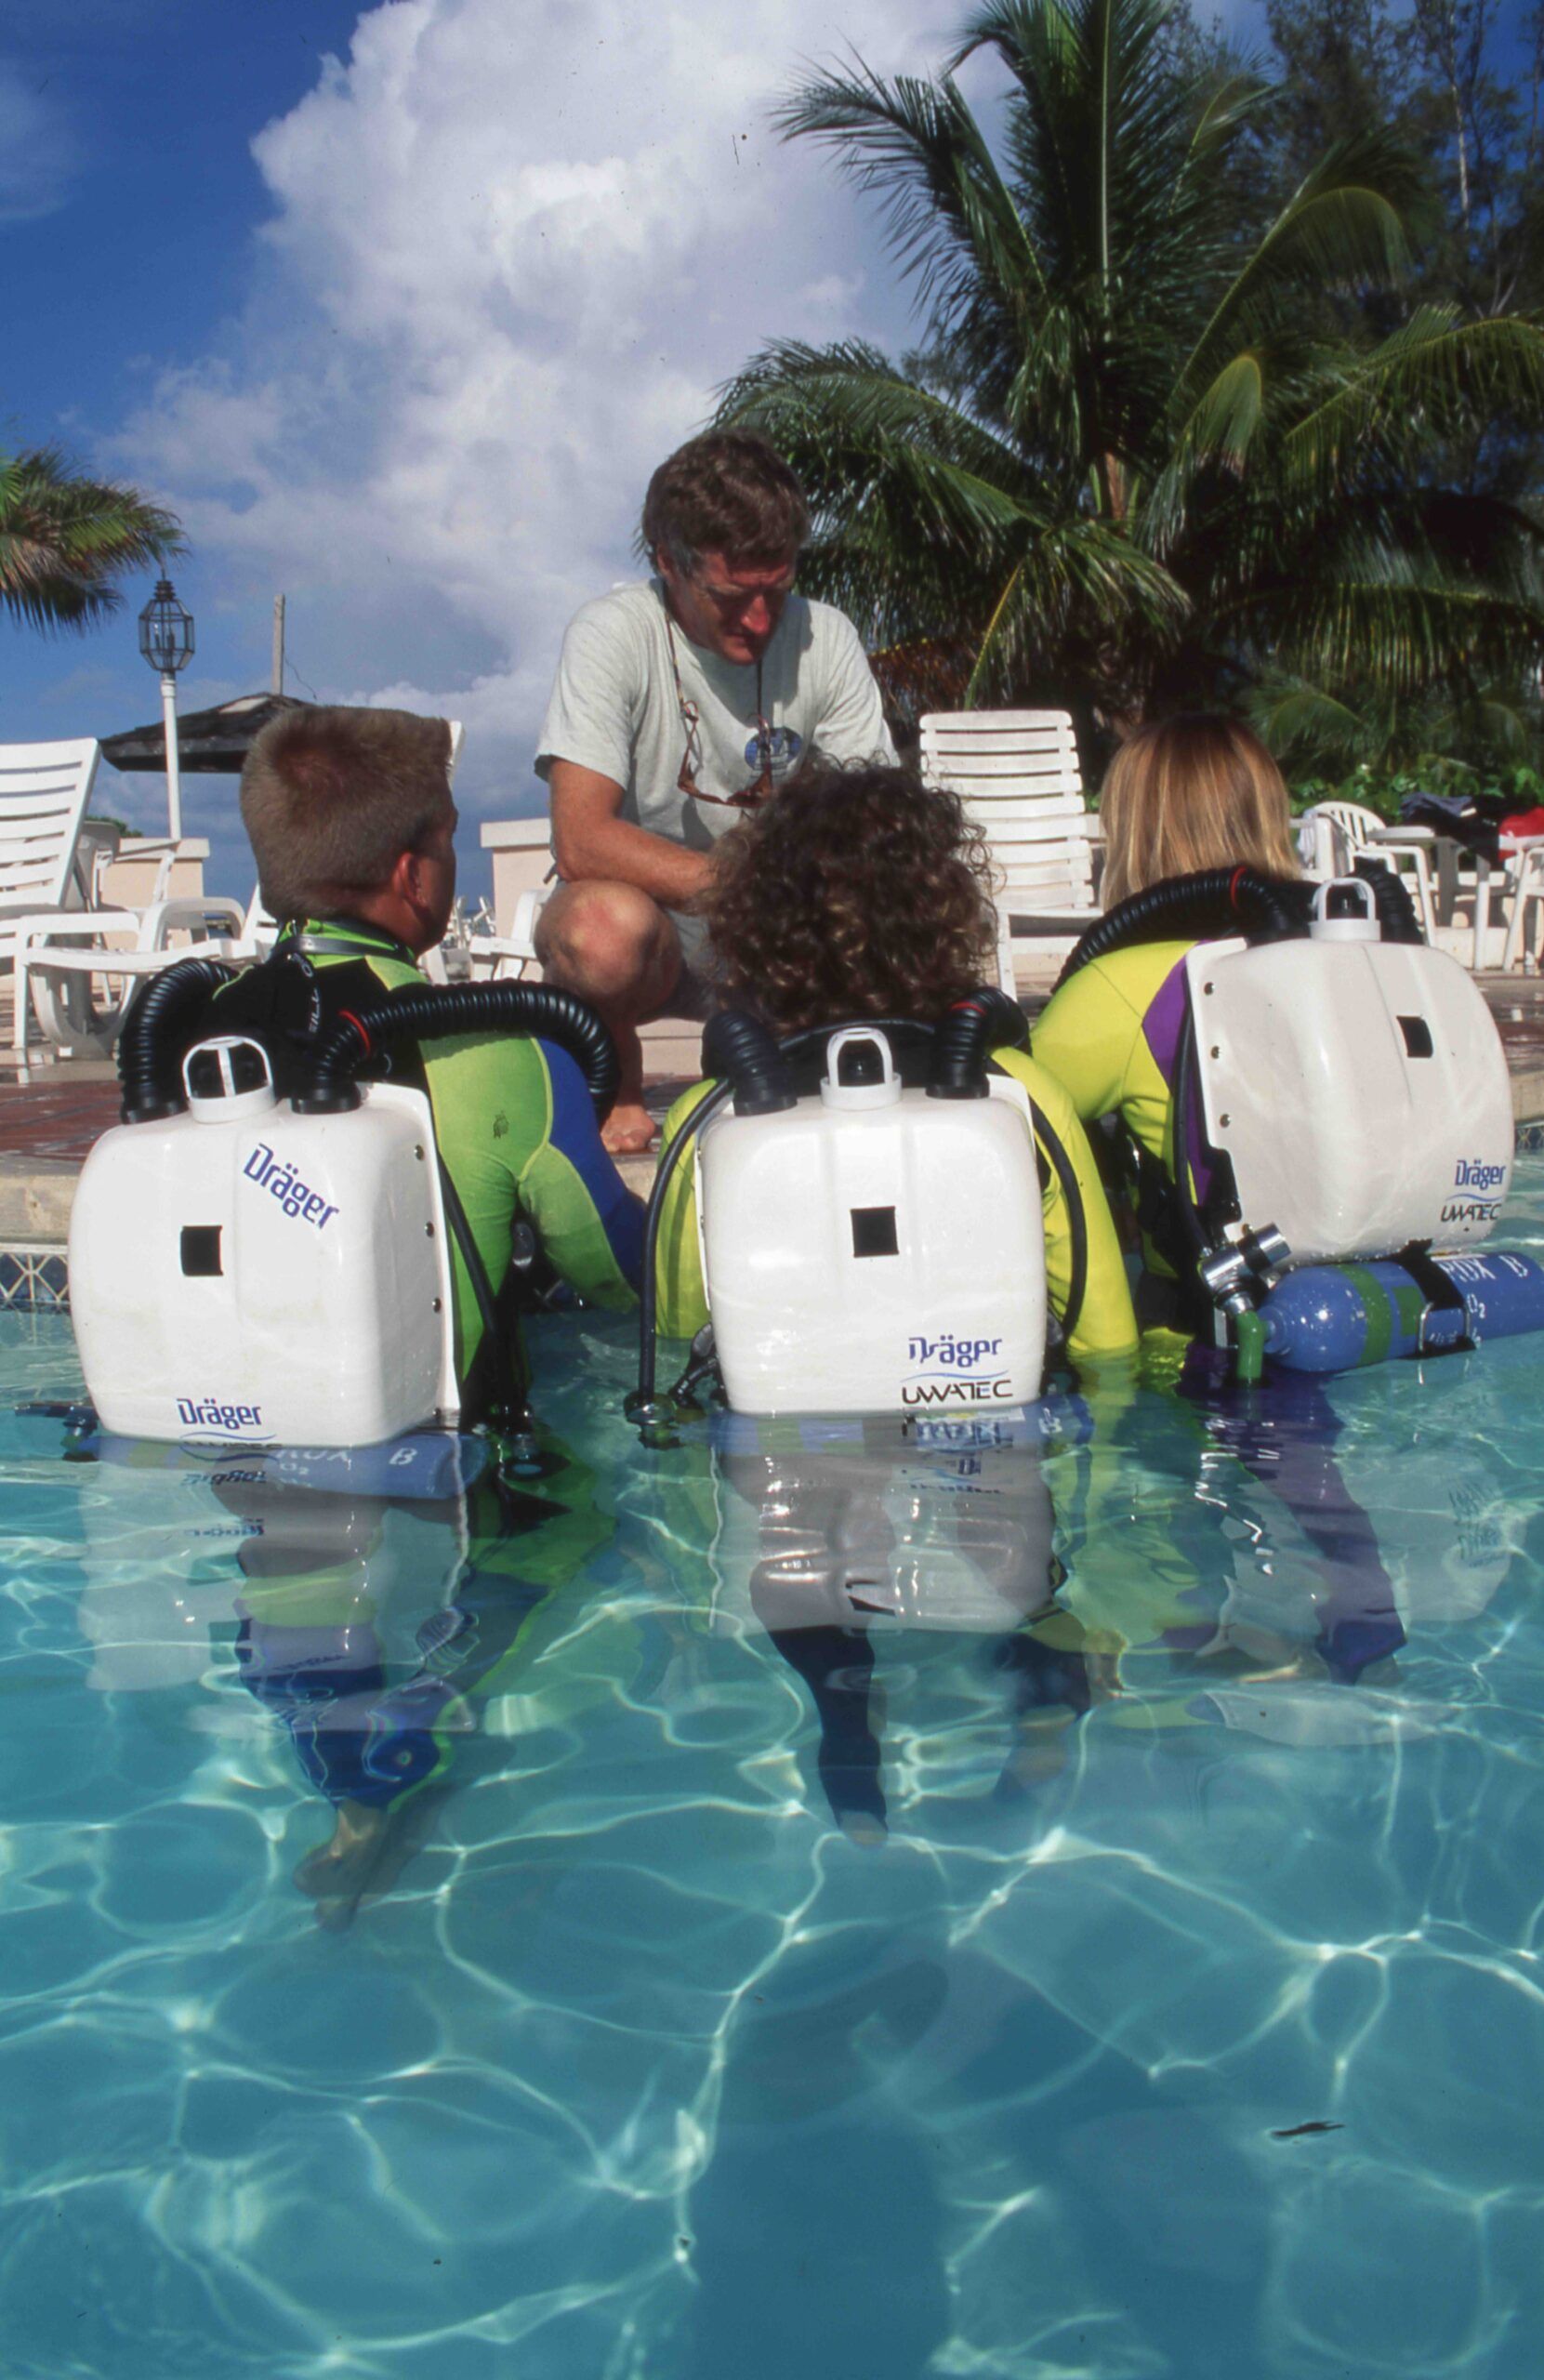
[[0, 447, 186, 630]]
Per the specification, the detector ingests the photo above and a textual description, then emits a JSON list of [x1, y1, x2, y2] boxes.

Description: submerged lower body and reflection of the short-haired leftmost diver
[[76, 1433, 614, 1928]]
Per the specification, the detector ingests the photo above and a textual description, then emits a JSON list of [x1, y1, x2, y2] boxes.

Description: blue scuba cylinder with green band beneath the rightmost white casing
[[1259, 1250, 1544, 1371]]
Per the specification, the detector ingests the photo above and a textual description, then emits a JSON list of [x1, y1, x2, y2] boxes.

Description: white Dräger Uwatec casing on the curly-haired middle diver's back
[[697, 1042, 1045, 1414]]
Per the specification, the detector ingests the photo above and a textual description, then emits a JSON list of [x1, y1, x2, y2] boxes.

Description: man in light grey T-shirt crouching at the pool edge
[[535, 430, 894, 1152]]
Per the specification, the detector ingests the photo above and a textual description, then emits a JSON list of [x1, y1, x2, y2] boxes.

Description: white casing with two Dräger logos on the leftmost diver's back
[[69, 1083, 459, 1447]]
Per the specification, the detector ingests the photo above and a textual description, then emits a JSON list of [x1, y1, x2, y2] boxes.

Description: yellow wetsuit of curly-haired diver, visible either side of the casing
[[654, 1050, 1137, 1364]]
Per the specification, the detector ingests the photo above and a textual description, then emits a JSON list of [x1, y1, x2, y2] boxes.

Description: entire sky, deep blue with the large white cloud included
[[0, 0, 1256, 895]]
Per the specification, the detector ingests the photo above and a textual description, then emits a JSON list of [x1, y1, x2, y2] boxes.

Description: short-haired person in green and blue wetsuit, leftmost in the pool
[[209, 709, 642, 1421]]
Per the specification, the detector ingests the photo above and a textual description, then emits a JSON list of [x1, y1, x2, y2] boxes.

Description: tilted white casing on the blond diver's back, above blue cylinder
[[1185, 940, 1515, 1263]]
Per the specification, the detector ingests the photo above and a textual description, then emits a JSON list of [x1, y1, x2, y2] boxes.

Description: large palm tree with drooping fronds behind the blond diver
[[719, 0, 1544, 747]]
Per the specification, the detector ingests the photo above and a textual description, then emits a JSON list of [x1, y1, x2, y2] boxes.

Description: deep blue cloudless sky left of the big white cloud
[[0, 0, 385, 890]]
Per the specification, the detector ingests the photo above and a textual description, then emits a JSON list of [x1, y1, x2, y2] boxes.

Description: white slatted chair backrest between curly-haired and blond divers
[[920, 711, 1099, 993]]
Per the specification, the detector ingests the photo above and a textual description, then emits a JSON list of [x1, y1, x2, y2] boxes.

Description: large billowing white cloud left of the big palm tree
[[119, 0, 957, 812]]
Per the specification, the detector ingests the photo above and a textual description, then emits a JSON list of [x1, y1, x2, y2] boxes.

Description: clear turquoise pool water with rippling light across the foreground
[[0, 1159, 1544, 2380]]
